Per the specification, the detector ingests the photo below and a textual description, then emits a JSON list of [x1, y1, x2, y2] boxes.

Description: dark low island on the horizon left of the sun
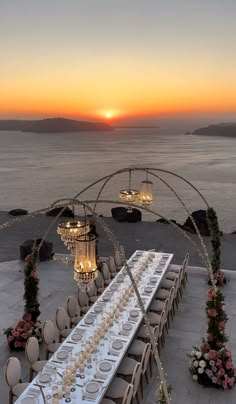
[[0, 118, 114, 133]]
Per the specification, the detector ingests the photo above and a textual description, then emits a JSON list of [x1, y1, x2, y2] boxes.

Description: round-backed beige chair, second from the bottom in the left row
[[25, 337, 47, 382]]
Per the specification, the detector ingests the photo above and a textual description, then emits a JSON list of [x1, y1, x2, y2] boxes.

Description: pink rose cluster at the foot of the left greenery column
[[4, 313, 42, 351]]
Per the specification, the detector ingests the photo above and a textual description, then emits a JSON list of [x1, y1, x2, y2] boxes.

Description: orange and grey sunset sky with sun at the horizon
[[0, 0, 236, 119]]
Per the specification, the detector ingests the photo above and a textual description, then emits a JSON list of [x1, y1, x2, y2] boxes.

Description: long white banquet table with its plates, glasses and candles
[[16, 250, 173, 404]]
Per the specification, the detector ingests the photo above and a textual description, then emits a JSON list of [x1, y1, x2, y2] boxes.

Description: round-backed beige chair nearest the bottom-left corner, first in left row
[[4, 357, 29, 404]]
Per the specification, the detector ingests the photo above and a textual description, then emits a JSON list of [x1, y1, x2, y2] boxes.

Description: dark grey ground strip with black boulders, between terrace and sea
[[0, 212, 236, 271]]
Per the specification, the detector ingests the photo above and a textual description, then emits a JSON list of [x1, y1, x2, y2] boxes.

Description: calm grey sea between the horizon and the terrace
[[0, 128, 236, 232]]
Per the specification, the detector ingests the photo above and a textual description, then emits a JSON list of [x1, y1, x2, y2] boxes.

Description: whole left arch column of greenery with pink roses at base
[[4, 247, 42, 351]]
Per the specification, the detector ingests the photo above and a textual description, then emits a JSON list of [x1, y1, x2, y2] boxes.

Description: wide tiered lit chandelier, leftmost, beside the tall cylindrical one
[[57, 221, 89, 255]]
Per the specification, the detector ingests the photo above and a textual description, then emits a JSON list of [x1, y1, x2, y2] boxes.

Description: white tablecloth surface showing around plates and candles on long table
[[16, 250, 173, 404]]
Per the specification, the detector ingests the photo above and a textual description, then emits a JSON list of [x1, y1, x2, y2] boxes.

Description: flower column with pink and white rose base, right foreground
[[189, 287, 236, 390]]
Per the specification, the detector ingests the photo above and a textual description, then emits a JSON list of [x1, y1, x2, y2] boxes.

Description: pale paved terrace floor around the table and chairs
[[0, 261, 236, 404]]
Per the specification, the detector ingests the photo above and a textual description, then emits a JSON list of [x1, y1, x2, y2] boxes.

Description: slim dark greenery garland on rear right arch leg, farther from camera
[[207, 208, 227, 285]]
